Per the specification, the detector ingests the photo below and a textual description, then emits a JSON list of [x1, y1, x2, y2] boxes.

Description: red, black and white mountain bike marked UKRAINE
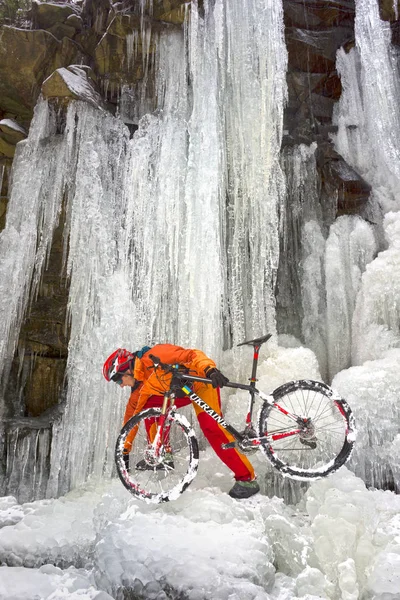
[[115, 334, 356, 504]]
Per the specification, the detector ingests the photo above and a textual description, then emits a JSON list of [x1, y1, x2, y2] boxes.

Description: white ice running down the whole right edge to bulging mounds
[[333, 0, 400, 490]]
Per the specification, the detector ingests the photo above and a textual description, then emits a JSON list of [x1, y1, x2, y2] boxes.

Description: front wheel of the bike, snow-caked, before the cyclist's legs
[[115, 408, 199, 504]]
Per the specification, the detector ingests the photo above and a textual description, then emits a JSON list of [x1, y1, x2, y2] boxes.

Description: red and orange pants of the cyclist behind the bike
[[125, 384, 255, 481]]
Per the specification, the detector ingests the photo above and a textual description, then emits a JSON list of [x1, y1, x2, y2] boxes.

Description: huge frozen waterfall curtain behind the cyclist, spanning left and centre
[[0, 0, 287, 498]]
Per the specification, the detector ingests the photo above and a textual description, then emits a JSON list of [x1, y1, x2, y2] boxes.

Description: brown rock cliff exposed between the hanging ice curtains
[[0, 0, 400, 480]]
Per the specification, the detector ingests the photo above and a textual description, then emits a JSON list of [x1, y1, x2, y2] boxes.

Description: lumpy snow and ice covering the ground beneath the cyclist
[[0, 450, 400, 600]]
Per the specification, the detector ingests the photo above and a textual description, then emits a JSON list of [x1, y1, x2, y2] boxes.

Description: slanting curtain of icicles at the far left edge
[[0, 101, 66, 392]]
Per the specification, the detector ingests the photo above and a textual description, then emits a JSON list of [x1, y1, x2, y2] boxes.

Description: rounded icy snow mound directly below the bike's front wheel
[[95, 492, 275, 600]]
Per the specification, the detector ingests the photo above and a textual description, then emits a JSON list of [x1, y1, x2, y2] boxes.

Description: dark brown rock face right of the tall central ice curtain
[[284, 0, 369, 214]]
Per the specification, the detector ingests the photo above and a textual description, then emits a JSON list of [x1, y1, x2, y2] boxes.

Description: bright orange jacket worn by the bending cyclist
[[123, 344, 216, 425]]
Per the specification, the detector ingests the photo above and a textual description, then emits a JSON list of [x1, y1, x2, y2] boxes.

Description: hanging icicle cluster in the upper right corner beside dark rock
[[334, 0, 400, 212]]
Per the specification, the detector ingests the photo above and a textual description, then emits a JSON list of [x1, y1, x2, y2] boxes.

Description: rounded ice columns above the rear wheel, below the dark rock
[[277, 144, 376, 381]]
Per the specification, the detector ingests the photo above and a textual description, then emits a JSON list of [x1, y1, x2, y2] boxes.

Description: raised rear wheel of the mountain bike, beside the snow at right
[[258, 380, 356, 480]]
